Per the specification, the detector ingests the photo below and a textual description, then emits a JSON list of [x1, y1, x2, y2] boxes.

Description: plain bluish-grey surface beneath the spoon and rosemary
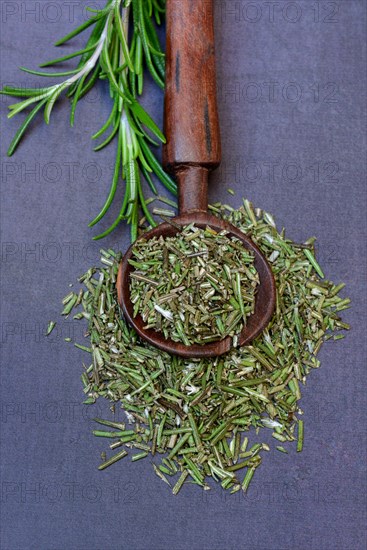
[[1, 0, 366, 550]]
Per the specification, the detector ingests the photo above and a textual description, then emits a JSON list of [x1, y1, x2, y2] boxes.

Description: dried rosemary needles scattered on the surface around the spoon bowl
[[64, 201, 350, 494]]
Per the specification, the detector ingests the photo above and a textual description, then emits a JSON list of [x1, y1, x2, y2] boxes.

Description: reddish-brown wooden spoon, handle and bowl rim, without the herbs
[[117, 0, 275, 357]]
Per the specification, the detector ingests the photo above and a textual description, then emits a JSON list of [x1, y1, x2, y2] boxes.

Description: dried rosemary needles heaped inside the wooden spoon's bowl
[[129, 224, 259, 346]]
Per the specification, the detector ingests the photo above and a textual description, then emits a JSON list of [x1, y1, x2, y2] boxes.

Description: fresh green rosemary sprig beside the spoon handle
[[0, 0, 176, 240]]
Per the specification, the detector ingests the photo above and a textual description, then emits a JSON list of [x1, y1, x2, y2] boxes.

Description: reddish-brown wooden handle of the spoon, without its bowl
[[163, 0, 221, 213]]
